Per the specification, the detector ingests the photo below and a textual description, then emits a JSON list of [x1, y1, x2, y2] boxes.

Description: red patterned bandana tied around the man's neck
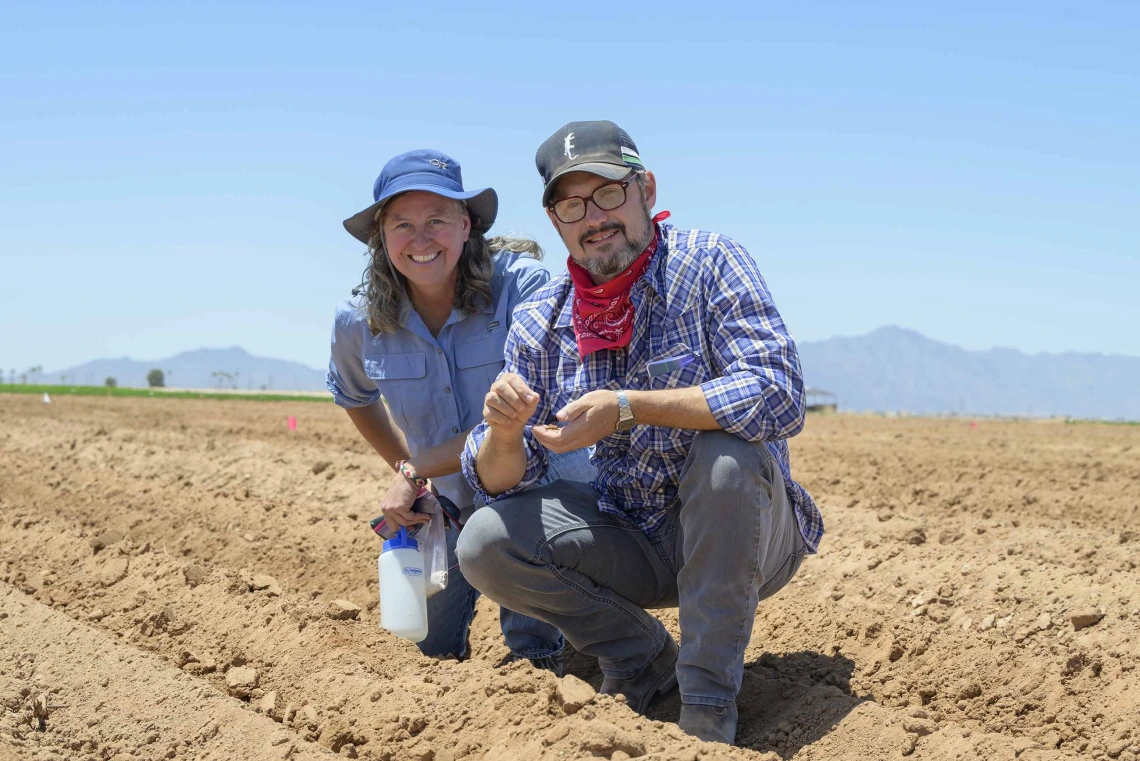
[[567, 212, 669, 359]]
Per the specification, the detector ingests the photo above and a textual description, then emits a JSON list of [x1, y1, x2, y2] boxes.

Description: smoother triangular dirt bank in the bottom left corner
[[0, 583, 333, 761]]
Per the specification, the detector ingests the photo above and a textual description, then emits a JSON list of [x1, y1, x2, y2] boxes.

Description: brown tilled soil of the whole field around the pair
[[0, 395, 1140, 761]]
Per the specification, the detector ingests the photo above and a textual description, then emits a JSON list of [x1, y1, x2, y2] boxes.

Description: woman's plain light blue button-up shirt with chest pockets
[[325, 252, 551, 508]]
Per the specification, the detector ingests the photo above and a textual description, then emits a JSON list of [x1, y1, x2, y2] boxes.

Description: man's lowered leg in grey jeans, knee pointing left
[[456, 481, 674, 697]]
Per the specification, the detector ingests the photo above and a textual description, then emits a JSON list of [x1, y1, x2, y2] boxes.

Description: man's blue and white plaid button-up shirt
[[462, 223, 823, 553]]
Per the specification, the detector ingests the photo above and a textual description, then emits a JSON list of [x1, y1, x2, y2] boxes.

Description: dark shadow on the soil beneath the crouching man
[[567, 650, 862, 759]]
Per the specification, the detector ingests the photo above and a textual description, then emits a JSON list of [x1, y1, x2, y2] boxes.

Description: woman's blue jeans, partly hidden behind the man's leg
[[418, 449, 597, 658]]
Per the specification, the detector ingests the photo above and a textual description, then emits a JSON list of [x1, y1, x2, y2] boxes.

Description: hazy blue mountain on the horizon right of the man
[[798, 327, 1140, 420]]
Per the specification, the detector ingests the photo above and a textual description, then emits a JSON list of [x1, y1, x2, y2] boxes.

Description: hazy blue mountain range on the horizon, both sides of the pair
[[31, 325, 1140, 420]]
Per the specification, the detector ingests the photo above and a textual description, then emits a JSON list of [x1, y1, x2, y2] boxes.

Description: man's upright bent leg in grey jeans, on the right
[[677, 431, 806, 744]]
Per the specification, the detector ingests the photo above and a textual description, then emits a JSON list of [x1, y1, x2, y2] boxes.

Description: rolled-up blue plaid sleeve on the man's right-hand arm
[[701, 238, 804, 441]]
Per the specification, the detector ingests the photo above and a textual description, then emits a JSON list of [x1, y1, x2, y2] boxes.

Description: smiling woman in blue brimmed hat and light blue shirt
[[327, 150, 593, 674]]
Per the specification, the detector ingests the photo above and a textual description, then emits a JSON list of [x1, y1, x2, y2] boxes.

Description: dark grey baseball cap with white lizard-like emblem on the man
[[535, 122, 645, 206]]
